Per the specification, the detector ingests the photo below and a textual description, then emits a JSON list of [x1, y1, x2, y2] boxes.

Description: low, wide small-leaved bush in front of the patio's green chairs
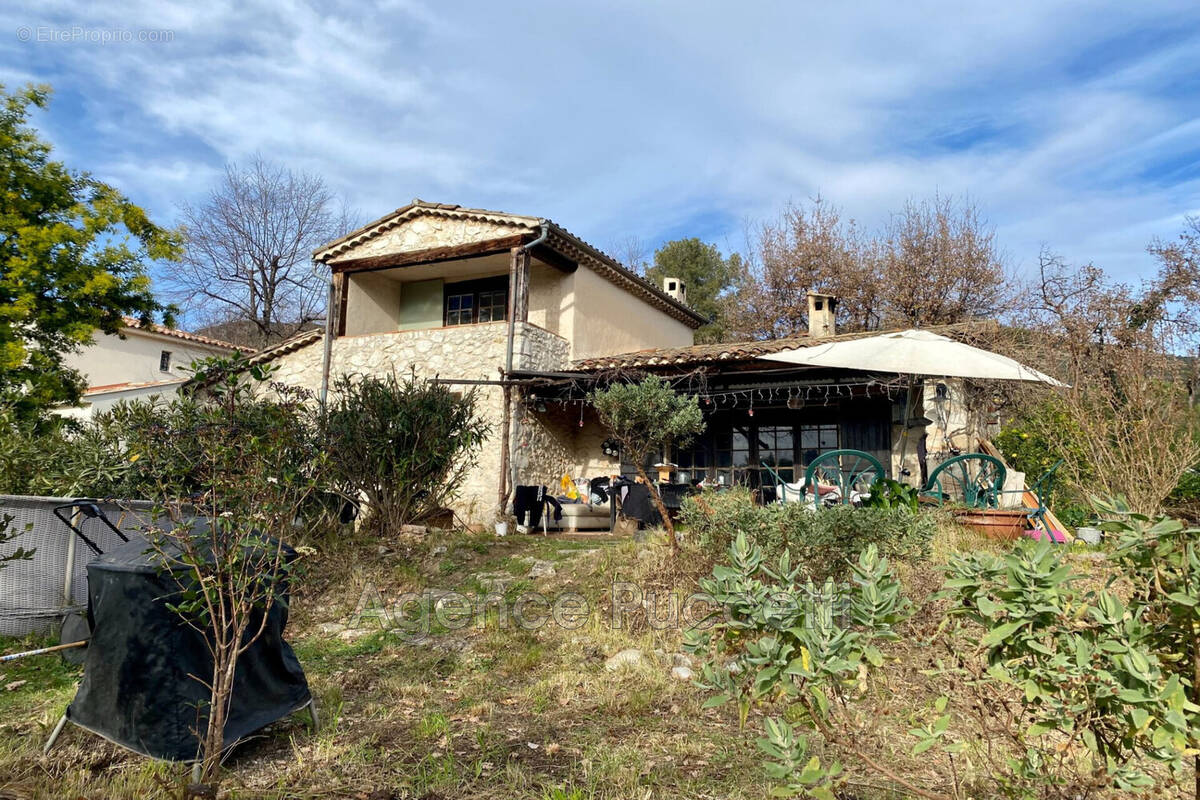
[[680, 489, 937, 579]]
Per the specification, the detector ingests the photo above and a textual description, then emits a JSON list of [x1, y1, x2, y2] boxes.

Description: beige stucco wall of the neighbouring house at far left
[[65, 329, 230, 386]]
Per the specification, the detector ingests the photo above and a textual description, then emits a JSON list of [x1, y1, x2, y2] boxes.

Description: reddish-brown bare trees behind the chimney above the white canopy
[[731, 196, 1015, 338]]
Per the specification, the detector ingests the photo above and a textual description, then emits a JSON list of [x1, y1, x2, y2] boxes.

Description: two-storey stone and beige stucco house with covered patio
[[253, 200, 985, 522]]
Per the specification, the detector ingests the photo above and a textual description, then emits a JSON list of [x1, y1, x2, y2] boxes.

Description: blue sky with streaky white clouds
[[0, 0, 1200, 291]]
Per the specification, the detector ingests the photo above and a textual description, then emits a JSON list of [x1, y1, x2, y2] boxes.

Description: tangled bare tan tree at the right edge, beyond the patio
[[1014, 247, 1200, 515]]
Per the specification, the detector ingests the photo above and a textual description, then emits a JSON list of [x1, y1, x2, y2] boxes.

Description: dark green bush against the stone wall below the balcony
[[325, 374, 490, 535]]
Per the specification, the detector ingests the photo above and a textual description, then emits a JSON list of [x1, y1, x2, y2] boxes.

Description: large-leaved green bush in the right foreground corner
[[946, 537, 1200, 798]]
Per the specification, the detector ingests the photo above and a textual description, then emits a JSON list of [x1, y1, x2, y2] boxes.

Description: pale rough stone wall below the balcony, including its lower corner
[[272, 323, 568, 523]]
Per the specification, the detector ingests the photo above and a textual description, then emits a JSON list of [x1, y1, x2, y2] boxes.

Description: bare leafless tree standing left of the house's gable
[[167, 155, 354, 347]]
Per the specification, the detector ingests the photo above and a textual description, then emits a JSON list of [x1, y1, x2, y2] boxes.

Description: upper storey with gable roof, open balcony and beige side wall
[[313, 200, 704, 359]]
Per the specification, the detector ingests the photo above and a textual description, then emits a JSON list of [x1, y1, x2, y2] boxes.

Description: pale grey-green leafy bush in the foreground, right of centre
[[685, 533, 912, 800]]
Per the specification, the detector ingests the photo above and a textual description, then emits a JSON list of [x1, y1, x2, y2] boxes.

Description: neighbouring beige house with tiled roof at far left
[[60, 317, 248, 417]]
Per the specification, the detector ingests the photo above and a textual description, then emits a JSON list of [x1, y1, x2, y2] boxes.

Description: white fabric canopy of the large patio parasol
[[760, 330, 1066, 386]]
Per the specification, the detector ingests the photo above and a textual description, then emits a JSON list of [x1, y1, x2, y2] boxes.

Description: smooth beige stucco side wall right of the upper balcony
[[564, 267, 695, 360]]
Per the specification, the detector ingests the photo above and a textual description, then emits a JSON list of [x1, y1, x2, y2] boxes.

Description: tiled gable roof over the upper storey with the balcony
[[313, 199, 708, 327]]
